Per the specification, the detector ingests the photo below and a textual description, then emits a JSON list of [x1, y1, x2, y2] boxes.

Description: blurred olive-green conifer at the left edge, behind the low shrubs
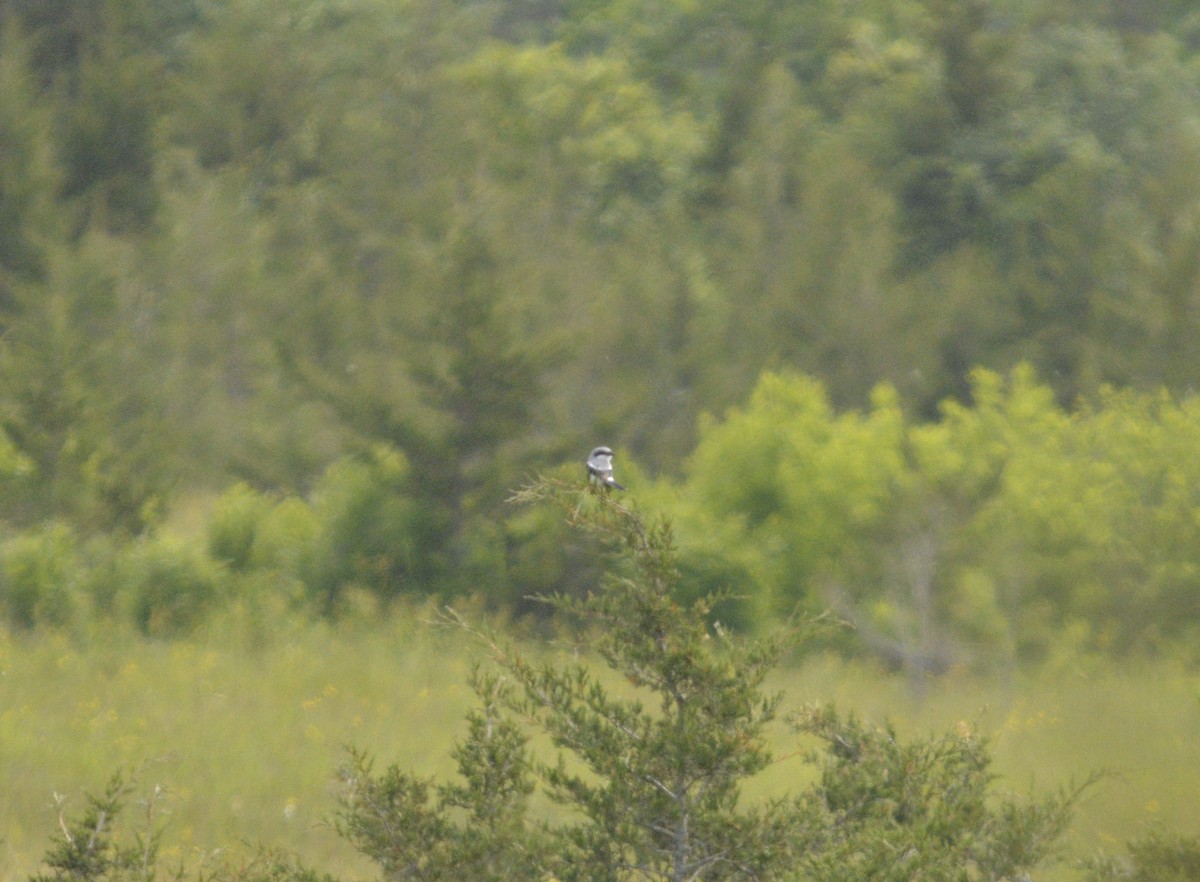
[[0, 236, 170, 533]]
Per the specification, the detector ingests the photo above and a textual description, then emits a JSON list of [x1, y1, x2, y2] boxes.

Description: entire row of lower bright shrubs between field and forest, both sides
[[5, 352, 1200, 677]]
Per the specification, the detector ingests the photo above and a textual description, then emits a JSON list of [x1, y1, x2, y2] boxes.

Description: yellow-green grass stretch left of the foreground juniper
[[0, 597, 470, 880]]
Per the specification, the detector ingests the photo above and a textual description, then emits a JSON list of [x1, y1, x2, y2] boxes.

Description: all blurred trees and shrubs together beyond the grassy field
[[0, 0, 1200, 677]]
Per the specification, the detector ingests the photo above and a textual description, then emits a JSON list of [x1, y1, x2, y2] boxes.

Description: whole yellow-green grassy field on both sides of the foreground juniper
[[0, 610, 1200, 882]]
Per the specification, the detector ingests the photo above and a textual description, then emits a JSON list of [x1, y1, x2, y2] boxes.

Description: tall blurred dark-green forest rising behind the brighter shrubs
[[0, 0, 1200, 528]]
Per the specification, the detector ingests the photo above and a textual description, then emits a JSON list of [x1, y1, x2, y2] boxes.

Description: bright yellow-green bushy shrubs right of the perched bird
[[679, 368, 1200, 671]]
